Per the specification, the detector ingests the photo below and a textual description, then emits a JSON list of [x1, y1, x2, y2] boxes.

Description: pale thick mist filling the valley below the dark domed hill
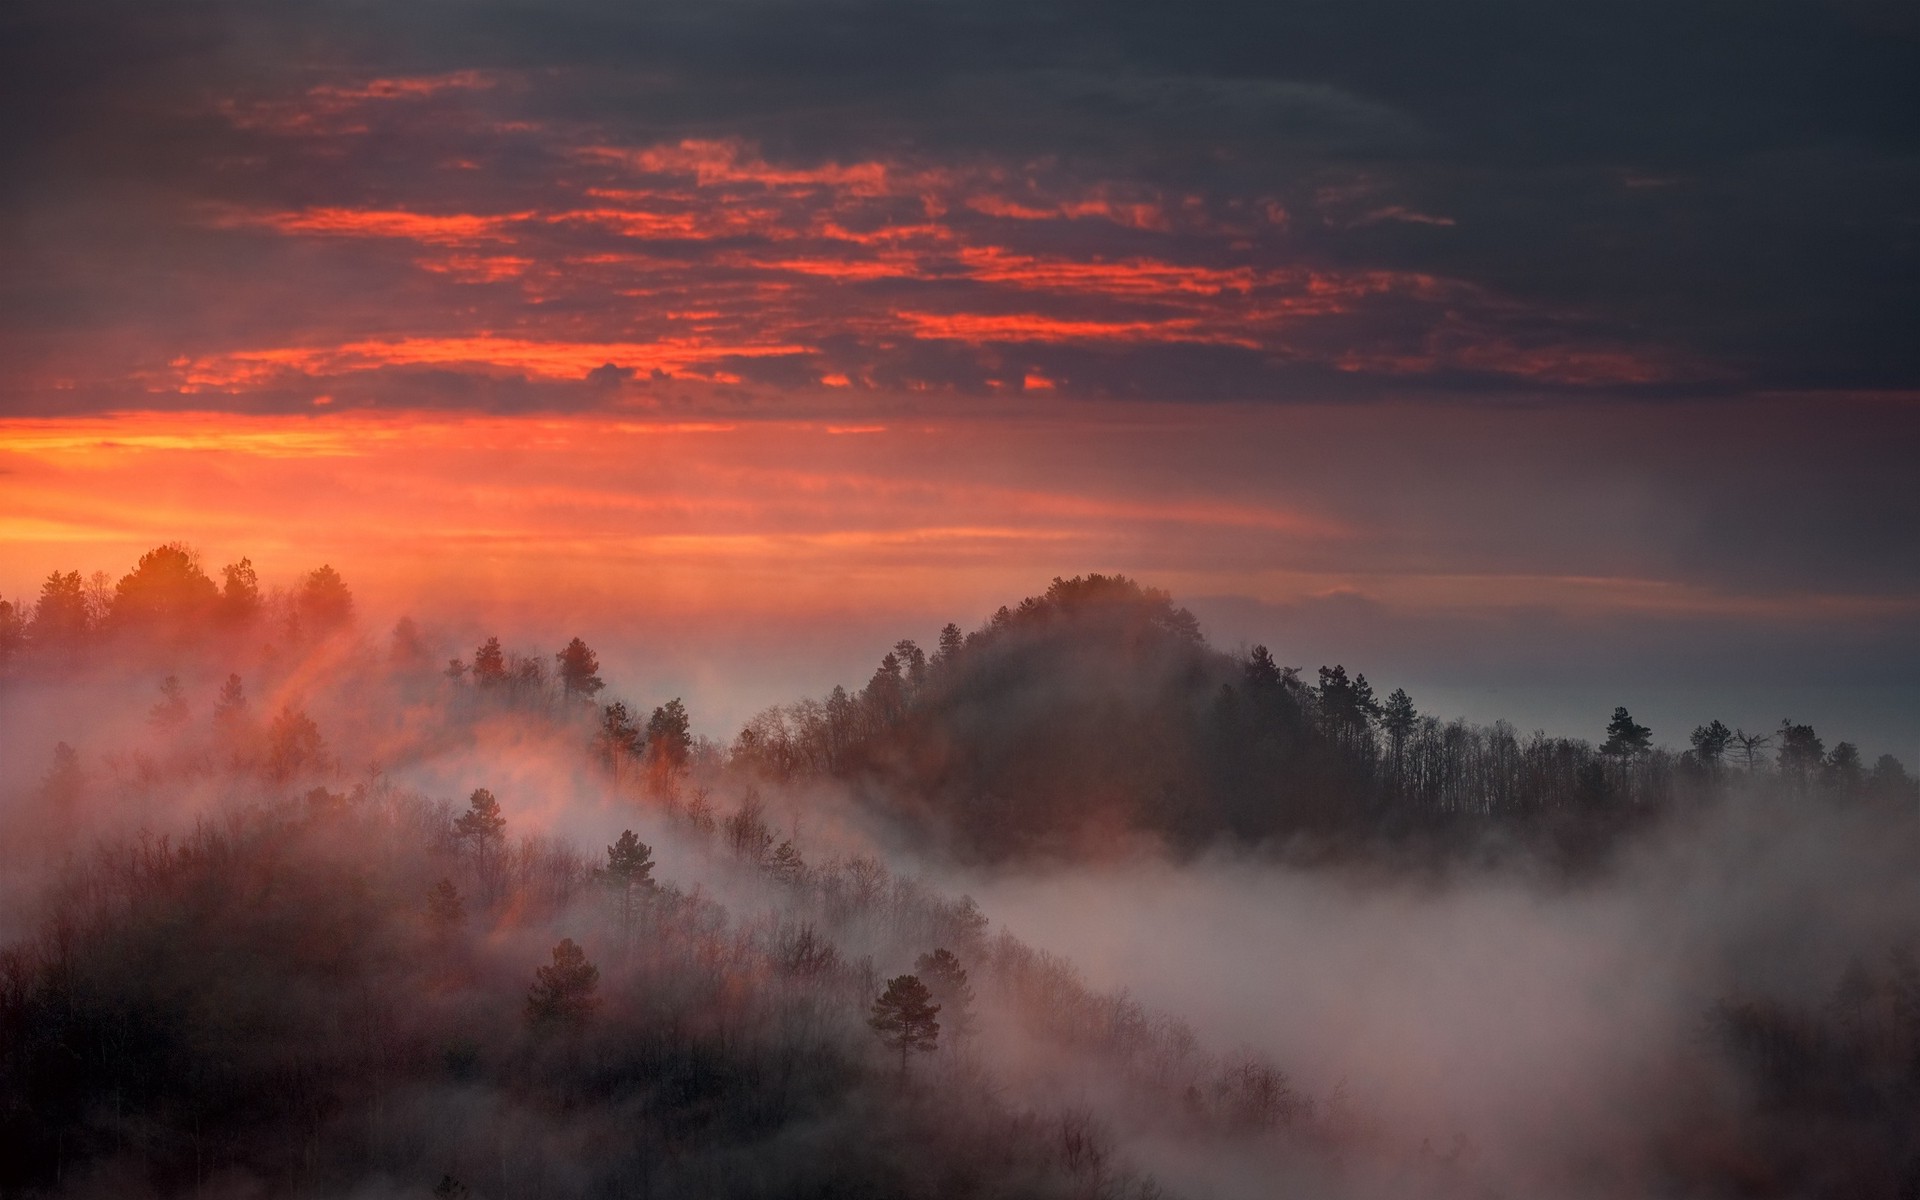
[[967, 797, 1920, 1196]]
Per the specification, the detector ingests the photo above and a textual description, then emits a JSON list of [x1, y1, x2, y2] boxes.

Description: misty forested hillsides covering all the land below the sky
[[0, 543, 1920, 1200]]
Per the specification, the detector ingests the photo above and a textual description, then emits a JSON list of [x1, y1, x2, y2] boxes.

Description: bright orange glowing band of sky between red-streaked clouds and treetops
[[0, 409, 1912, 633]]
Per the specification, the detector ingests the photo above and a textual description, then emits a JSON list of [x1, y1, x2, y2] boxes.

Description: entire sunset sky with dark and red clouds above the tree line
[[0, 0, 1920, 748]]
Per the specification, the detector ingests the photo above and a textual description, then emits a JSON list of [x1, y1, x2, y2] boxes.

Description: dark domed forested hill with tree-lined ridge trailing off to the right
[[732, 574, 1916, 858]]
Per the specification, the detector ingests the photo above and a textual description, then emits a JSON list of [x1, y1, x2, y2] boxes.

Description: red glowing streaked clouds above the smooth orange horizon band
[[18, 71, 1701, 407]]
